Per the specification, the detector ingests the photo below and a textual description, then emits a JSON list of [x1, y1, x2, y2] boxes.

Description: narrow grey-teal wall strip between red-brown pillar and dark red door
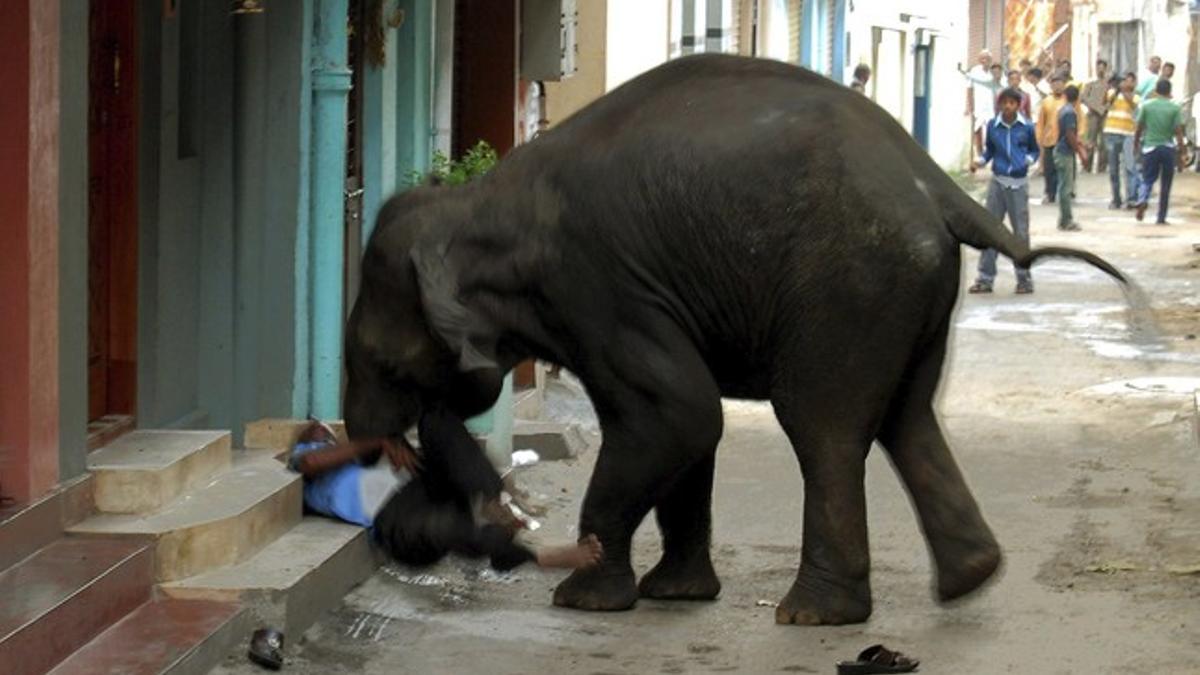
[[59, 0, 88, 480]]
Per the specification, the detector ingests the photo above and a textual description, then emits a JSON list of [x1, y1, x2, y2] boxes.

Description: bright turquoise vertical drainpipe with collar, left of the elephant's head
[[308, 0, 352, 419]]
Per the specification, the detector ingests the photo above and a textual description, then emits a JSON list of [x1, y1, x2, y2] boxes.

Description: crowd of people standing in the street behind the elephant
[[964, 50, 1188, 293]]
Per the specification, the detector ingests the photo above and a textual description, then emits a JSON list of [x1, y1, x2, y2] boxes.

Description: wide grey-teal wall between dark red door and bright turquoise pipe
[[138, 0, 311, 442]]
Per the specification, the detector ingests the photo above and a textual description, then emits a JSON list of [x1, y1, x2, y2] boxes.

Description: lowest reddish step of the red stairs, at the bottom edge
[[50, 598, 248, 675]]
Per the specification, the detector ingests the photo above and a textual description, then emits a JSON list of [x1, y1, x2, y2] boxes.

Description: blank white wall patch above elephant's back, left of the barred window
[[605, 0, 671, 91]]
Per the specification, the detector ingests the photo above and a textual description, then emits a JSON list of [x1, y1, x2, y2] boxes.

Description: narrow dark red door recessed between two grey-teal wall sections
[[88, 0, 138, 431]]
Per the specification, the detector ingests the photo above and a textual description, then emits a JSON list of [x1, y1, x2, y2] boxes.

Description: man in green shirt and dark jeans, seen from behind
[[1133, 79, 1186, 225]]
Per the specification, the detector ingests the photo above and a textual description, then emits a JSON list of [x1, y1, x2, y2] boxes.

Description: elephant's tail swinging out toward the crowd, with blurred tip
[[942, 181, 1158, 341]]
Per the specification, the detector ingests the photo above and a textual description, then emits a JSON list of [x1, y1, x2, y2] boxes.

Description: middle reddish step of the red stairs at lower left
[[0, 537, 154, 675]]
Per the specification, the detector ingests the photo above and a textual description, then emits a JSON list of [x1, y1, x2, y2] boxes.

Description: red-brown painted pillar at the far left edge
[[0, 0, 59, 501]]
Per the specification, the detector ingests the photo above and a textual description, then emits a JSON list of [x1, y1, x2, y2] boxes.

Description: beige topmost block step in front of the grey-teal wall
[[88, 430, 233, 514]]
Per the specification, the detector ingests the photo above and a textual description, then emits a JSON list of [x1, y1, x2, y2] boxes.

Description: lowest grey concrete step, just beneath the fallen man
[[161, 516, 382, 635]]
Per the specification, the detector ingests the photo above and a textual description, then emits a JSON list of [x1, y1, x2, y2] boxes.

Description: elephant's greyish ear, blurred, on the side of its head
[[409, 241, 499, 372]]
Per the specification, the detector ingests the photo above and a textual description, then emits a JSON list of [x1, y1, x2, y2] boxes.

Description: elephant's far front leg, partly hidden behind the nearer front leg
[[637, 448, 721, 601]]
